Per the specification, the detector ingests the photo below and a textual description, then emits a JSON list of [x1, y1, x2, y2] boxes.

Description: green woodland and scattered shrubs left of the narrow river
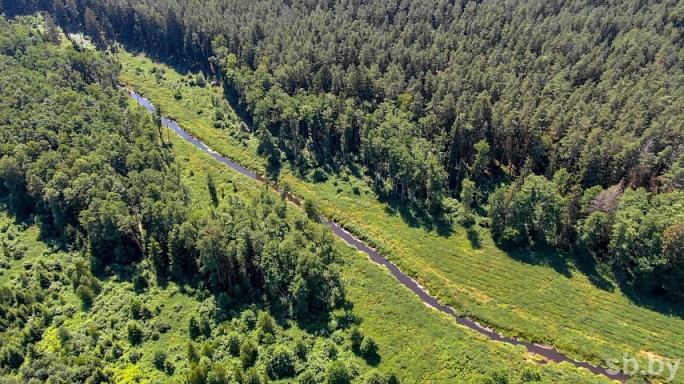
[[0, 16, 408, 384]]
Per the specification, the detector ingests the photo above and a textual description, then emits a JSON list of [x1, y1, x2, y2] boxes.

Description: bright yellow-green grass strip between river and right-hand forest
[[121, 50, 684, 380]]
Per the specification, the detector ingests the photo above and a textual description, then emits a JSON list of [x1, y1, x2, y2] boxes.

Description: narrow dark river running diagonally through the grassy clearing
[[126, 90, 630, 382]]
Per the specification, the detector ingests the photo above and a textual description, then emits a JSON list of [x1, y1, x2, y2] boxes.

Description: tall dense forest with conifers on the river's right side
[[2, 0, 684, 300]]
